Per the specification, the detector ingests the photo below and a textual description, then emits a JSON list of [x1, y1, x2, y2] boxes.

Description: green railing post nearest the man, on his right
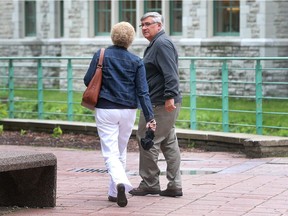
[[190, 60, 197, 130]]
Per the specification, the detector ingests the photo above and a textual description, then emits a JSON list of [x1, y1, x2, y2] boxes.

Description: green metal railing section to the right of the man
[[180, 57, 288, 134]]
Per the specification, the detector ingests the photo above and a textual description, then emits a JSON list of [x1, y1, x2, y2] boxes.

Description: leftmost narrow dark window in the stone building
[[24, 1, 36, 37]]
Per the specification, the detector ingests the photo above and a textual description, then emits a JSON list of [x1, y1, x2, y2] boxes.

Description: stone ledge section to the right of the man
[[177, 129, 288, 158]]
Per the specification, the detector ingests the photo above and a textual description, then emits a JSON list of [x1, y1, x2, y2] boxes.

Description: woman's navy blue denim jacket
[[84, 45, 154, 122]]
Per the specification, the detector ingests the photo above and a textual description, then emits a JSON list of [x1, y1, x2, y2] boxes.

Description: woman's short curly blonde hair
[[111, 22, 135, 49]]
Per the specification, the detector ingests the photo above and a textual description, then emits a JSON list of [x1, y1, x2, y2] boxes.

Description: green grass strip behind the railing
[[0, 89, 288, 136]]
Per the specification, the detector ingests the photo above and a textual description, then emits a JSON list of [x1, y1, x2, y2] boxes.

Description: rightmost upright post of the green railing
[[255, 59, 263, 135]]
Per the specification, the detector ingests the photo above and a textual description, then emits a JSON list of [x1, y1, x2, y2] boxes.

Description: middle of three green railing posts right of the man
[[222, 60, 229, 132]]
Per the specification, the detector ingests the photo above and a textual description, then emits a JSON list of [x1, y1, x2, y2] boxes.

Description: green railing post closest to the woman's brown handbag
[[67, 59, 73, 121]]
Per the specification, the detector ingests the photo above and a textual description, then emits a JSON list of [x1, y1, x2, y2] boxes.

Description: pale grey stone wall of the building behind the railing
[[0, 0, 288, 96]]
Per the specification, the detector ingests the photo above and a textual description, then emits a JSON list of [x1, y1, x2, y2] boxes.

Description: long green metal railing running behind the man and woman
[[0, 57, 288, 136]]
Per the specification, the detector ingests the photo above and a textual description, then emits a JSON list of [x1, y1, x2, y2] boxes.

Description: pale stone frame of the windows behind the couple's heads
[[89, 0, 183, 37]]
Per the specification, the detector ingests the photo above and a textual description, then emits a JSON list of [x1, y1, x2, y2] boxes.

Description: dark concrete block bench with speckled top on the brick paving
[[0, 150, 57, 208]]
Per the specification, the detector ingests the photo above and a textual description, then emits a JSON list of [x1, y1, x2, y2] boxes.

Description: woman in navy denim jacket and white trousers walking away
[[84, 22, 156, 207]]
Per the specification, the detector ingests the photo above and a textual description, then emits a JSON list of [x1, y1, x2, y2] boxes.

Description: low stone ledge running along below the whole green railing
[[0, 119, 288, 158]]
